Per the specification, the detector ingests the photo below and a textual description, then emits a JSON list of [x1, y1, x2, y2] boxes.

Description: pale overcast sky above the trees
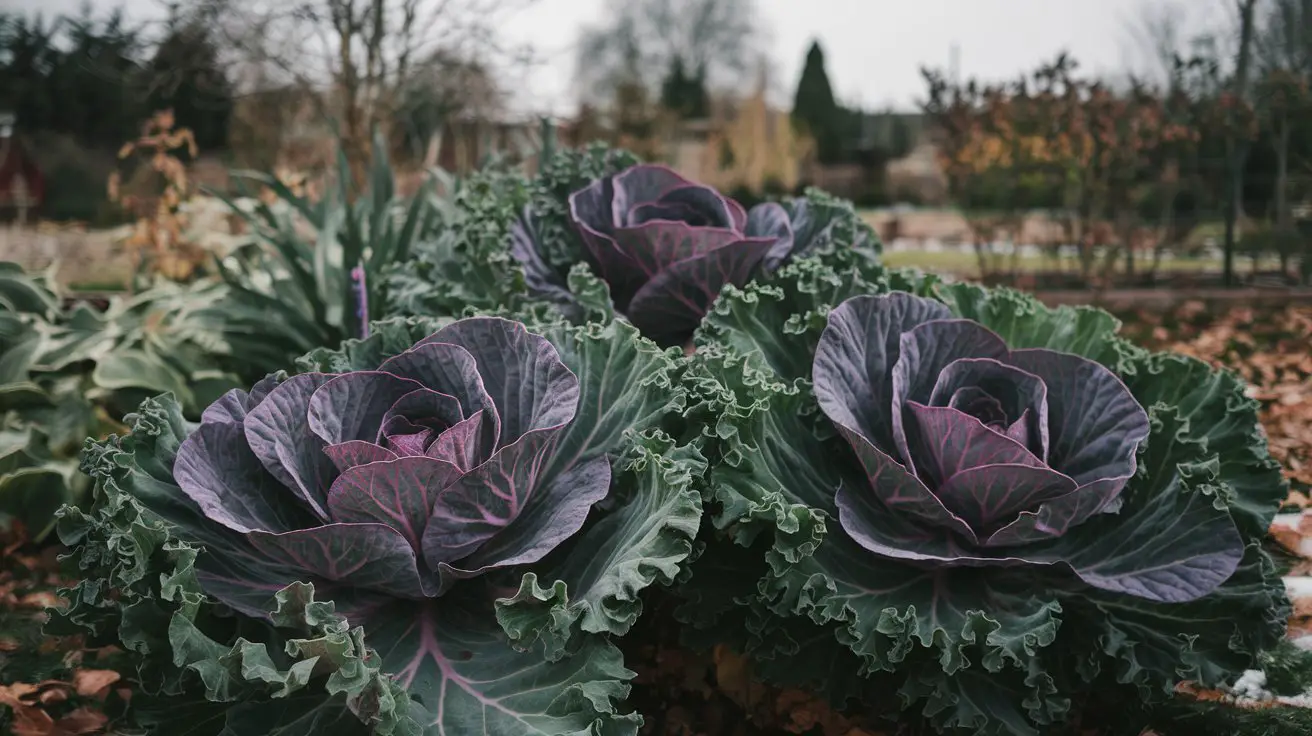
[[10, 0, 1219, 113]]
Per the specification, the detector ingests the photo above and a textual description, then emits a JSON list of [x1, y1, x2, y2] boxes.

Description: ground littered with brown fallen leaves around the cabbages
[[0, 299, 1312, 736]]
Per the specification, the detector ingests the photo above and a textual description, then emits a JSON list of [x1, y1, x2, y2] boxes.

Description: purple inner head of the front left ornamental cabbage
[[173, 317, 610, 610]]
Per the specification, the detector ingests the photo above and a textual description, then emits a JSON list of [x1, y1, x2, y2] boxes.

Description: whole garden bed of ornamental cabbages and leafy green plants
[[0, 148, 1312, 736]]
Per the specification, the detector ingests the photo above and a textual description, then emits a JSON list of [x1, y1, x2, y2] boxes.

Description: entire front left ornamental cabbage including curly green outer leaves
[[59, 317, 705, 736]]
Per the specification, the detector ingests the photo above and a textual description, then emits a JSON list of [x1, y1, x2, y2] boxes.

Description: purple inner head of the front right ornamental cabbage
[[812, 294, 1242, 601]]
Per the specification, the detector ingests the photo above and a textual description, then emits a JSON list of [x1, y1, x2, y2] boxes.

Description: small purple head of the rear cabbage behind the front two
[[569, 164, 794, 345]]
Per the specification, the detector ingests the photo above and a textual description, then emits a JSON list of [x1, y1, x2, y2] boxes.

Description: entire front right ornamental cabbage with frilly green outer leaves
[[684, 264, 1287, 733]]
